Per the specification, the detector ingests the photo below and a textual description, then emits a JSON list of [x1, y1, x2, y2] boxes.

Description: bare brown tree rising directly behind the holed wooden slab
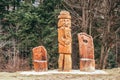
[[63, 0, 100, 69]]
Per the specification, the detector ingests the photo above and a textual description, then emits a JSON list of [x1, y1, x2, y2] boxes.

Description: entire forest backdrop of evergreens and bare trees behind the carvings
[[0, 0, 120, 71]]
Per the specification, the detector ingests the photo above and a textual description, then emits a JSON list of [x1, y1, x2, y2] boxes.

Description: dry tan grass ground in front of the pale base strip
[[0, 68, 120, 80]]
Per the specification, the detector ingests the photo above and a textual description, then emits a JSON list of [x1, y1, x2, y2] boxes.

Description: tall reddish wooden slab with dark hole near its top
[[78, 33, 95, 71]]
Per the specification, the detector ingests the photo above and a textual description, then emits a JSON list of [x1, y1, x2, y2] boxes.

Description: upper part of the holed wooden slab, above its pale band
[[78, 33, 94, 59]]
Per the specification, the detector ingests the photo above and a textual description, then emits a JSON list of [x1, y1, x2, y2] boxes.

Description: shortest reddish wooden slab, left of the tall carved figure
[[32, 46, 48, 72]]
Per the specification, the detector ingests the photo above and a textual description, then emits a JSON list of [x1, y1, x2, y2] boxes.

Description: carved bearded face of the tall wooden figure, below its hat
[[58, 19, 71, 28]]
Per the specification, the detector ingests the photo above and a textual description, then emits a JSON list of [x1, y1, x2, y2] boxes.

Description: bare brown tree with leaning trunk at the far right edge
[[100, 0, 119, 69]]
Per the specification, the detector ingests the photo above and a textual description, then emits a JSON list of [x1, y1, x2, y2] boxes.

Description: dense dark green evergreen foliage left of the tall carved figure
[[2, 0, 62, 68]]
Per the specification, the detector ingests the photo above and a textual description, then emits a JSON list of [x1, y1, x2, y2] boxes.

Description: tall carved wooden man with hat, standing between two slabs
[[58, 11, 72, 71]]
